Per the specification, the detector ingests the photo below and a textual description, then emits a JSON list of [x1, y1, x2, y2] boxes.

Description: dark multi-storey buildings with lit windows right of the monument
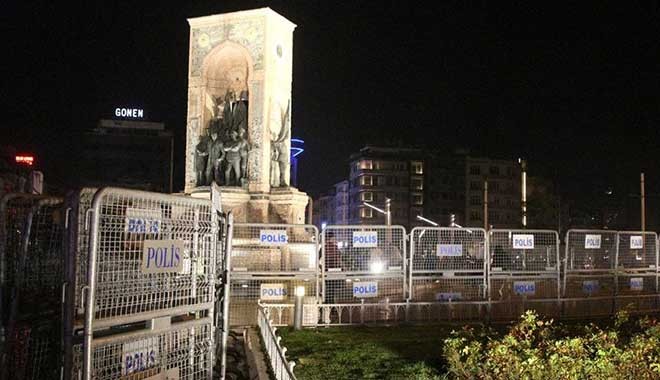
[[315, 146, 521, 228]]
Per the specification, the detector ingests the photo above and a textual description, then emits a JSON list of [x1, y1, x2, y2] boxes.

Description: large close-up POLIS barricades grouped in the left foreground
[[0, 188, 231, 379]]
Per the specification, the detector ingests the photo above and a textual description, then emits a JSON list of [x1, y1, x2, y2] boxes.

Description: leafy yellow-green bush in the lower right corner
[[443, 311, 660, 380]]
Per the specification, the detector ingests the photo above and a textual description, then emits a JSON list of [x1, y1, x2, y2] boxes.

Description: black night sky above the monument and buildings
[[0, 0, 660, 199]]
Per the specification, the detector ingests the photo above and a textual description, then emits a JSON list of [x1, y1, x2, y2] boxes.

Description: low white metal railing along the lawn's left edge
[[257, 301, 298, 380]]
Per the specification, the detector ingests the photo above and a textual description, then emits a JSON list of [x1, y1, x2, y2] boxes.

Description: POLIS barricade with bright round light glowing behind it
[[321, 225, 407, 308]]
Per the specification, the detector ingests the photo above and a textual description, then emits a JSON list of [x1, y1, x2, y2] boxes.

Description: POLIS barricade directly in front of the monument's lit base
[[229, 223, 319, 326]]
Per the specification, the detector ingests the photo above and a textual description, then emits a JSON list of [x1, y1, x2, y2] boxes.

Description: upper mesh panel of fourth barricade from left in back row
[[489, 230, 559, 275]]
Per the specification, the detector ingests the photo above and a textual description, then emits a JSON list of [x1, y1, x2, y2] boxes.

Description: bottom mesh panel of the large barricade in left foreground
[[91, 323, 213, 380]]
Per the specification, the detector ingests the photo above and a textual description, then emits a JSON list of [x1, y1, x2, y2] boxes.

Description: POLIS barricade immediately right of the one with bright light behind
[[408, 227, 488, 318]]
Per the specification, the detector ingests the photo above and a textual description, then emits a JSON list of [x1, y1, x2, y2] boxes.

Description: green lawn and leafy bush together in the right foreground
[[279, 312, 660, 380]]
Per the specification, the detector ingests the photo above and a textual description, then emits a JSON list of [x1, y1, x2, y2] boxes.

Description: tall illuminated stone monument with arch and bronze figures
[[185, 8, 308, 224]]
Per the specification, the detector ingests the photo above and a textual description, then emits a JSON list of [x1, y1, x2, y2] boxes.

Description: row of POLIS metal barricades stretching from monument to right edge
[[230, 224, 660, 324]]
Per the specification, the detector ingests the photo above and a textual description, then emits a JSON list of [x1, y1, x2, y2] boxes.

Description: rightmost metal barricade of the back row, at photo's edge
[[615, 231, 658, 310]]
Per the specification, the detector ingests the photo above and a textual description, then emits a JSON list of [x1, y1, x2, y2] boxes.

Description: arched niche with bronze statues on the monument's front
[[196, 41, 253, 186]]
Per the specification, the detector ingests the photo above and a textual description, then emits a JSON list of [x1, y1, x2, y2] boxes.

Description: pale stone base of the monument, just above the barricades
[[190, 186, 309, 224]]
